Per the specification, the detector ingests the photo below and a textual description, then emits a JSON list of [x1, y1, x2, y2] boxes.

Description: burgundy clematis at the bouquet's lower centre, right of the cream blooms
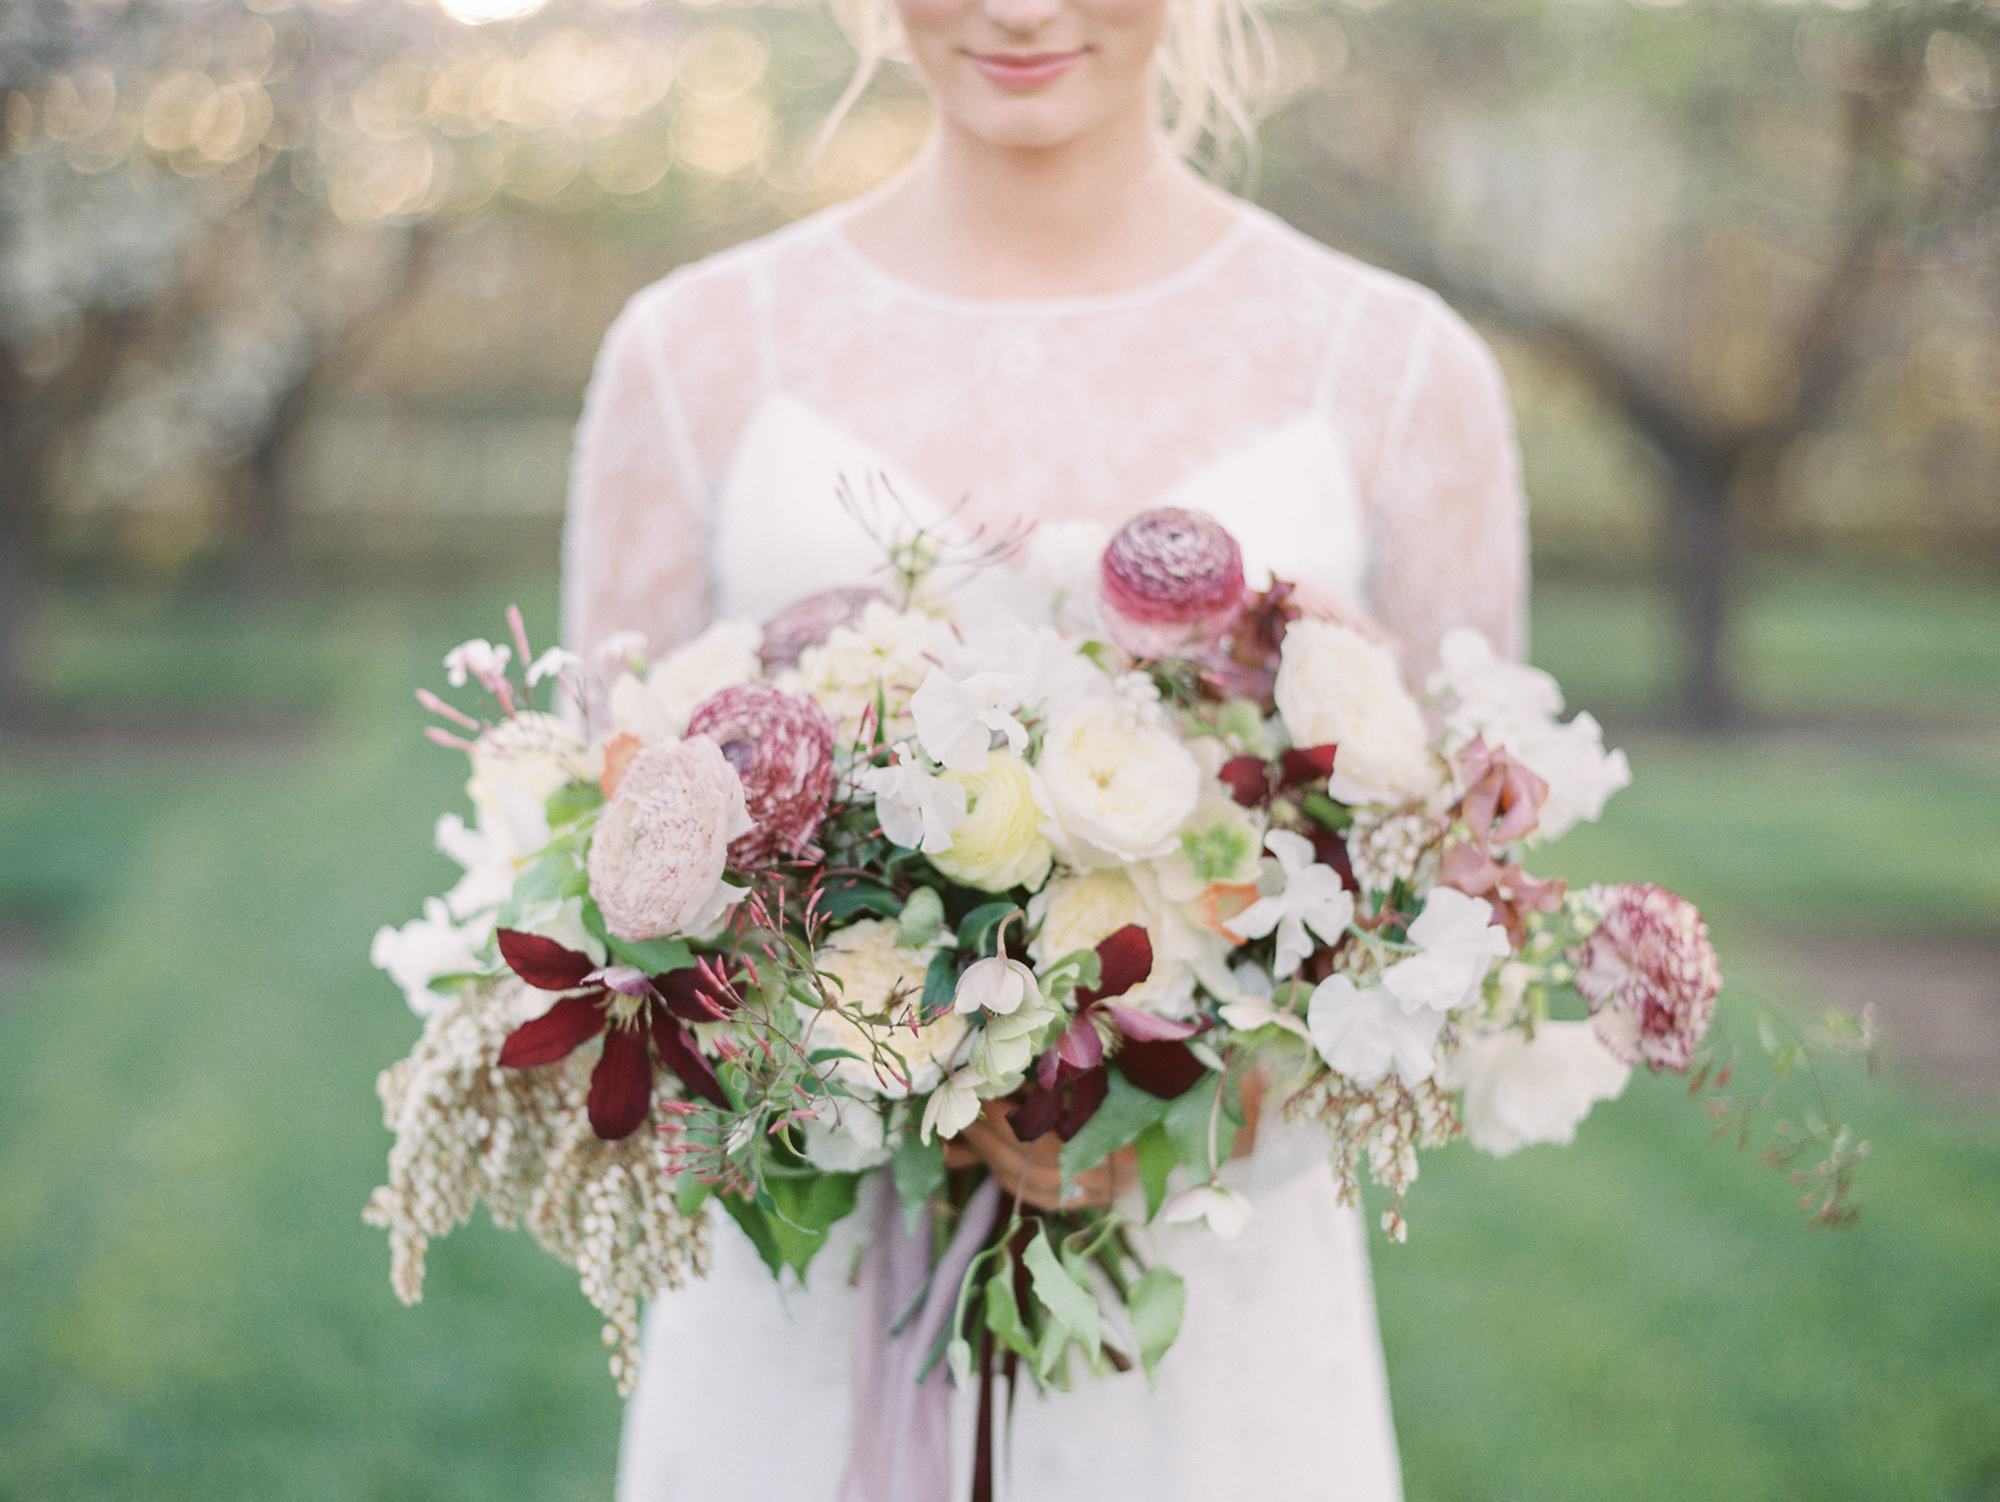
[[1006, 924, 1206, 1142]]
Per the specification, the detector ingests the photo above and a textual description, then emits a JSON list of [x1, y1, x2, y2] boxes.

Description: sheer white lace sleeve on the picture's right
[[1366, 300, 1528, 686]]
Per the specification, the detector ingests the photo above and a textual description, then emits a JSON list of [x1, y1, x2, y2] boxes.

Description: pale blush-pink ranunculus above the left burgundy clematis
[[586, 736, 754, 944]]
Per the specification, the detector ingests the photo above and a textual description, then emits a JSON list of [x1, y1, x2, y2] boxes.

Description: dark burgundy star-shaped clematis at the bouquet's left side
[[498, 928, 736, 1142]]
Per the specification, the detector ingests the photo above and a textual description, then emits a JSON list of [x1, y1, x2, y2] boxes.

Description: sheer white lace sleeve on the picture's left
[[562, 294, 710, 654]]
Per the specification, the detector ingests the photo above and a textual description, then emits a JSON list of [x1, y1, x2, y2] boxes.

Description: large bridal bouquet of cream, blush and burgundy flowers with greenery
[[368, 510, 1720, 1386]]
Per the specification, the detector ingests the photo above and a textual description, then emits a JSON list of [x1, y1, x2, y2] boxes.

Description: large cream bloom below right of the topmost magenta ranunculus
[[1274, 620, 1438, 804]]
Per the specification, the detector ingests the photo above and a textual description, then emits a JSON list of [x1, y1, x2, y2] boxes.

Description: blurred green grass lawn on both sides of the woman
[[0, 572, 2000, 1502]]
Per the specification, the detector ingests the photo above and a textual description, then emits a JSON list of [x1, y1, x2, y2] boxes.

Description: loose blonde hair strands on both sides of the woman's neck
[[820, 0, 1272, 176]]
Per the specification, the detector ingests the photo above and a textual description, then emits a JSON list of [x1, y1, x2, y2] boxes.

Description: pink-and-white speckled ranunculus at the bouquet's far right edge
[[1570, 886, 1722, 1070]]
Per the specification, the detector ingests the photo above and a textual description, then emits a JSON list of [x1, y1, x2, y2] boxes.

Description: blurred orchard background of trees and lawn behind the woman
[[0, 0, 2000, 1502]]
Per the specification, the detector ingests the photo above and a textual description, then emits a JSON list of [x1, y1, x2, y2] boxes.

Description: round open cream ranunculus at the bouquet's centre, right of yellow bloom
[[1038, 698, 1202, 866]]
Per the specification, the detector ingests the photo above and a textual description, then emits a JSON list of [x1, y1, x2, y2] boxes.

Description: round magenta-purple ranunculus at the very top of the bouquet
[[1098, 506, 1244, 658]]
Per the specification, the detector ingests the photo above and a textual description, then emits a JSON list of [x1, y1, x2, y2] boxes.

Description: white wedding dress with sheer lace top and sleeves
[[564, 197, 1526, 1502]]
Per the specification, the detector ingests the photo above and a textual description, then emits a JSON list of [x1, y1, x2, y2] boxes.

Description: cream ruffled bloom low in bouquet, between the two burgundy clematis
[[800, 918, 970, 1100]]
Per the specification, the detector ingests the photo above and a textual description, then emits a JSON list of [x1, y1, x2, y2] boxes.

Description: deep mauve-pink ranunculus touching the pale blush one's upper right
[[688, 684, 834, 866]]
